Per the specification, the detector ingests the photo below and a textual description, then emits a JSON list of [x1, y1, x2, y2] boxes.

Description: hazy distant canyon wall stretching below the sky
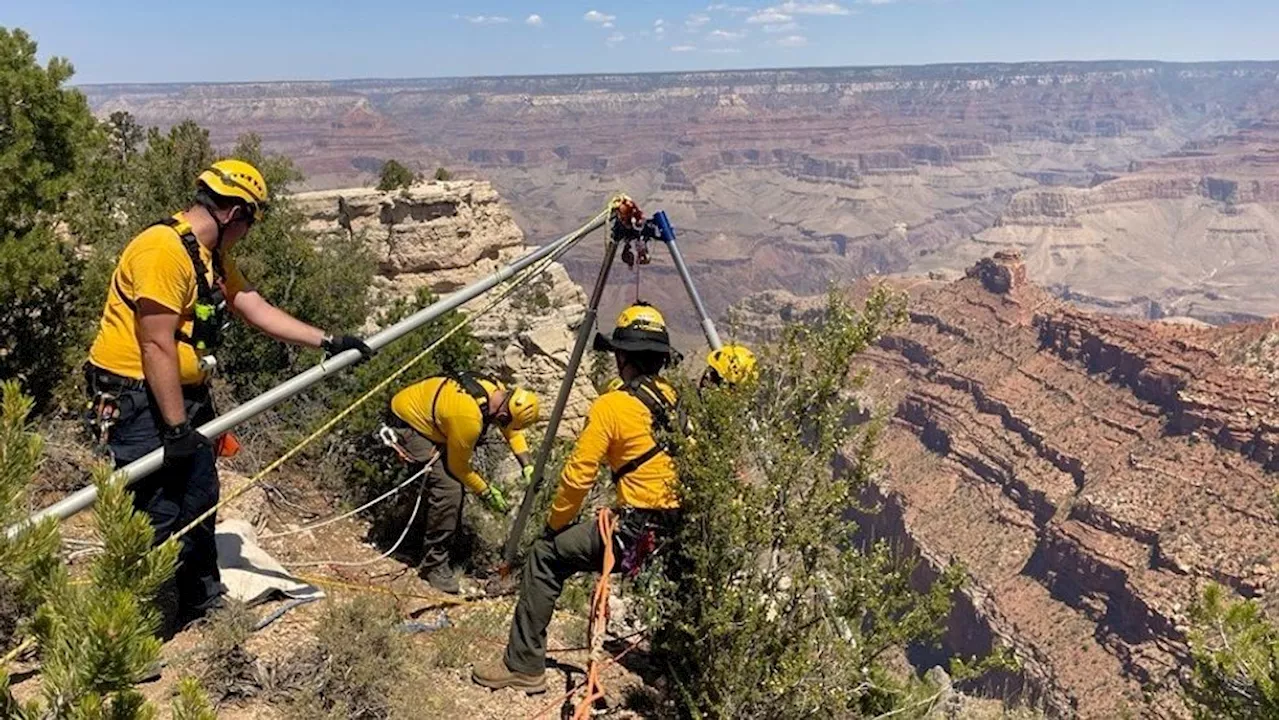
[[84, 61, 1280, 340]]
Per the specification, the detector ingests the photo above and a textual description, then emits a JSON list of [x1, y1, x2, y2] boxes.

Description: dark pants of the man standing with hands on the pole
[[99, 376, 224, 620]]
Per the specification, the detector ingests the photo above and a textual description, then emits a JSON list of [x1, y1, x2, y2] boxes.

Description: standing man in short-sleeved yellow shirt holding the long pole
[[84, 160, 371, 634]]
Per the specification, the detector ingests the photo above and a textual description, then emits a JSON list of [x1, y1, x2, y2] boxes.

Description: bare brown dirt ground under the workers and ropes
[[14, 458, 644, 720]]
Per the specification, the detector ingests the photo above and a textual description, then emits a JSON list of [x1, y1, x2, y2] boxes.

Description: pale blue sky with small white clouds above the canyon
[[0, 0, 1280, 83]]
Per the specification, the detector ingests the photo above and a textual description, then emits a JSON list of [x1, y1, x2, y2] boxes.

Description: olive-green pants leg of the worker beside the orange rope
[[506, 516, 604, 675]]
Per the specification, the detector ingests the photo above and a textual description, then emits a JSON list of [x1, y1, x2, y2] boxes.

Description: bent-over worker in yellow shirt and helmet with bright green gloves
[[381, 373, 538, 594]]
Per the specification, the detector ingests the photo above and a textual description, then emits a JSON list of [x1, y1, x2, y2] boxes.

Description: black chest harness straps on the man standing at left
[[111, 215, 230, 372]]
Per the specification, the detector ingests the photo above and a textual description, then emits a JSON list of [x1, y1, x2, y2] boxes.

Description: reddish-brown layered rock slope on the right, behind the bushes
[[737, 252, 1280, 719]]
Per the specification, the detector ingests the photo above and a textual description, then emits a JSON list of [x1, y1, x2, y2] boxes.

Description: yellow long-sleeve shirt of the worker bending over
[[392, 378, 529, 493]]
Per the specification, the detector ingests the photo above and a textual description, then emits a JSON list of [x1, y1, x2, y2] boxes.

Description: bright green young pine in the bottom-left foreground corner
[[0, 380, 222, 720]]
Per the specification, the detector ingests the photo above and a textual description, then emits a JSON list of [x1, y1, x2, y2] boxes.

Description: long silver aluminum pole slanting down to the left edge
[[5, 213, 608, 538]]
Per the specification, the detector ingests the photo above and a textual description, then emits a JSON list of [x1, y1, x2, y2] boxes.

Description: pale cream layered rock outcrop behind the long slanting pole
[[293, 181, 595, 434]]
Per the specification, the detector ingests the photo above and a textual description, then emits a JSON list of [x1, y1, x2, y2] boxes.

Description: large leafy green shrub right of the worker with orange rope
[[641, 290, 960, 717]]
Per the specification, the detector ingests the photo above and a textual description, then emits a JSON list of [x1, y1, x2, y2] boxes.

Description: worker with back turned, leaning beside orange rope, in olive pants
[[471, 304, 680, 694]]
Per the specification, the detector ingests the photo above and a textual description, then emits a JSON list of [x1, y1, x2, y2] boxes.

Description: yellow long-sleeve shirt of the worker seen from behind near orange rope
[[547, 383, 680, 530]]
